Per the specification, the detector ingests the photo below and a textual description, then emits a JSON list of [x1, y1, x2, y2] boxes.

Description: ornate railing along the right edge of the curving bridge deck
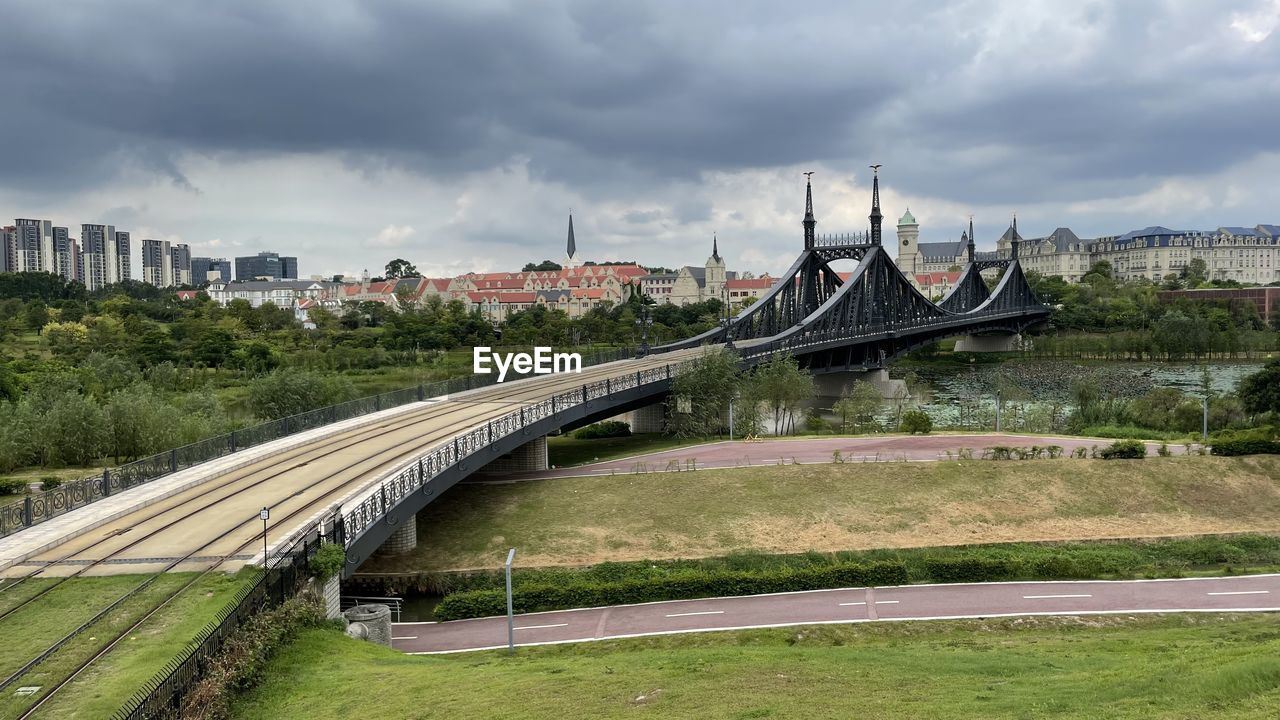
[[343, 361, 687, 547]]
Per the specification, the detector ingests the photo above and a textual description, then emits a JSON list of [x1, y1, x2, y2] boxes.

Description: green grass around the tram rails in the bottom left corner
[[0, 571, 251, 719]]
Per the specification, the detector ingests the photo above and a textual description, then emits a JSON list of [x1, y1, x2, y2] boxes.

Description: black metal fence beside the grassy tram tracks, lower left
[[113, 516, 342, 720]]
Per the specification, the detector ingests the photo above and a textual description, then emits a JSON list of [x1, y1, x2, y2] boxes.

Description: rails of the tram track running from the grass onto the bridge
[[0, 348, 691, 717]]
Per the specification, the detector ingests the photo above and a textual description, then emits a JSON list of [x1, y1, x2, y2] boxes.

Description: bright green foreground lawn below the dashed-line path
[[234, 615, 1280, 720]]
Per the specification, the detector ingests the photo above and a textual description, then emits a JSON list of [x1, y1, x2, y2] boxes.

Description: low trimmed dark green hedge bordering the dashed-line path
[[435, 562, 908, 620]]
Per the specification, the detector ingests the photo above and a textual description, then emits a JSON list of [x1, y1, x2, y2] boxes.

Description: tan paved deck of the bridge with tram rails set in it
[[0, 348, 703, 578]]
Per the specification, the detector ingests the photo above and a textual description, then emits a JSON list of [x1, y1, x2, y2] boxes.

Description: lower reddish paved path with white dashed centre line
[[392, 575, 1280, 655]]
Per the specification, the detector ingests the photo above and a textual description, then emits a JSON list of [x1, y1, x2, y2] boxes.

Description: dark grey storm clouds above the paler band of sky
[[0, 1, 1280, 206]]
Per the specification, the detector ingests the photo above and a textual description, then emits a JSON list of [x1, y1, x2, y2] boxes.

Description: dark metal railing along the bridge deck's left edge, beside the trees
[[0, 348, 635, 538]]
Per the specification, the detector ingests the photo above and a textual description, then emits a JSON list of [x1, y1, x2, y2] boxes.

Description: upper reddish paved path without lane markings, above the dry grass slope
[[468, 433, 1185, 483]]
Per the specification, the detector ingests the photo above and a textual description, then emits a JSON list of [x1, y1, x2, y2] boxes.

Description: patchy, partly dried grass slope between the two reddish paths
[[361, 456, 1280, 573]]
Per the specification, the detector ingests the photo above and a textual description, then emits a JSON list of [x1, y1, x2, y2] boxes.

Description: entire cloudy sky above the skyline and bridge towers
[[0, 0, 1280, 275]]
